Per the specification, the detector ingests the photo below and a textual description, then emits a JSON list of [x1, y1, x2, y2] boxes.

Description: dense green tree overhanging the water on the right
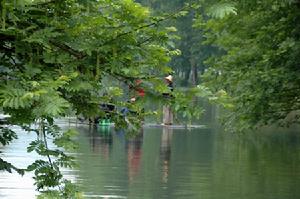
[[198, 0, 300, 130]]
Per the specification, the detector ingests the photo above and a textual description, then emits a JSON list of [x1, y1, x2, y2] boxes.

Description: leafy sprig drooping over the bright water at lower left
[[25, 120, 77, 198]]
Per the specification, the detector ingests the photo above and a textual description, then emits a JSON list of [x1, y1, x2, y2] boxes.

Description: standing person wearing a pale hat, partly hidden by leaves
[[163, 75, 174, 125]]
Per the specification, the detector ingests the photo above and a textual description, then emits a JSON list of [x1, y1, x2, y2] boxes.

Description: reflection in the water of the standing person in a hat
[[160, 128, 173, 183]]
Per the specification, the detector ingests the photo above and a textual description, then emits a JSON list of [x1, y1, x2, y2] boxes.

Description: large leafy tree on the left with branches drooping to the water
[[0, 0, 192, 197]]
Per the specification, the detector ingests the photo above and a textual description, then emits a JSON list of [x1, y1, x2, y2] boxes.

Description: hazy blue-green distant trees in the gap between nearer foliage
[[139, 0, 215, 86]]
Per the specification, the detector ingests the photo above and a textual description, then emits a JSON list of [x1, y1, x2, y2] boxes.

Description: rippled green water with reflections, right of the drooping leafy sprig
[[74, 127, 300, 199]]
